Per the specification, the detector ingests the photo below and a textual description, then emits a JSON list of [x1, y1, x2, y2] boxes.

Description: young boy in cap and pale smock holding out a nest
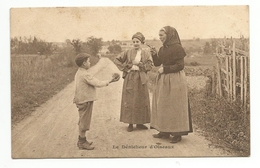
[[73, 53, 119, 150]]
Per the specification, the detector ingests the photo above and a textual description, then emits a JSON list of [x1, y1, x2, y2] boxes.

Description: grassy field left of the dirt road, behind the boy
[[11, 53, 77, 123]]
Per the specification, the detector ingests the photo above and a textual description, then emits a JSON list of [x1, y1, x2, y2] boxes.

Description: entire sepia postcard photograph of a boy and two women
[[10, 5, 250, 159]]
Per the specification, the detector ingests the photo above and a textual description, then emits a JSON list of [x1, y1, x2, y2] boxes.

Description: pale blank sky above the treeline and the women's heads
[[10, 6, 249, 42]]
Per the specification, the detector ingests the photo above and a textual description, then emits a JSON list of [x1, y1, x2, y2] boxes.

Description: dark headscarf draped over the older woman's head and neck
[[160, 26, 181, 46]]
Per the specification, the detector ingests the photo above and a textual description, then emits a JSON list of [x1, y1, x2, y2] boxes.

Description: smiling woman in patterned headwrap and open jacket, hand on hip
[[114, 32, 153, 132]]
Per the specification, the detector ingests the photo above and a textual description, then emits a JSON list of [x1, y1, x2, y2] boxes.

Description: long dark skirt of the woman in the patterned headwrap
[[120, 71, 150, 124]]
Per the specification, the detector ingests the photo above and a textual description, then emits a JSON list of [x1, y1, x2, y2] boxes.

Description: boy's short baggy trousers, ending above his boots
[[76, 101, 93, 131]]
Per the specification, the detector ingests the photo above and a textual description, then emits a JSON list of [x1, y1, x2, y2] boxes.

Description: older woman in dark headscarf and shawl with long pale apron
[[150, 26, 192, 143]]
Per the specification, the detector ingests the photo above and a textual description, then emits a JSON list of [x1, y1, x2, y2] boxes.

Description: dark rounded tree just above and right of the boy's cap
[[87, 36, 103, 55]]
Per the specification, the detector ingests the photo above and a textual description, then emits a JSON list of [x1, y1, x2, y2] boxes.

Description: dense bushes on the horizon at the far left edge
[[11, 37, 58, 55]]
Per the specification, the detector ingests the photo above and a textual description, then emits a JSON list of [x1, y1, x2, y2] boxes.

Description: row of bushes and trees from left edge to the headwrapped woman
[[10, 36, 122, 56]]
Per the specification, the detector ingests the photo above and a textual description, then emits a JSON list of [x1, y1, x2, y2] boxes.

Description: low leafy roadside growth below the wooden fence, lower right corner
[[189, 86, 250, 156]]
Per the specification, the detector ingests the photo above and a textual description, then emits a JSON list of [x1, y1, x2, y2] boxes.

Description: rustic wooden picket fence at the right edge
[[212, 40, 250, 107]]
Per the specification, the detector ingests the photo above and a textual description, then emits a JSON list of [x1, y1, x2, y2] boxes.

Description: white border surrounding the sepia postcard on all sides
[[0, 0, 260, 168]]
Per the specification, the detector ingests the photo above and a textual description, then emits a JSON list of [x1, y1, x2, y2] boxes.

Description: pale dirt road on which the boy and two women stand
[[12, 70, 231, 158]]
